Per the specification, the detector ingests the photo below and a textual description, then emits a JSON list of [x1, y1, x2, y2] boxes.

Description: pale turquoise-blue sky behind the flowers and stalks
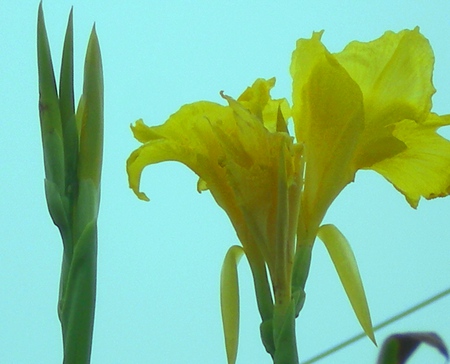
[[0, 0, 450, 364]]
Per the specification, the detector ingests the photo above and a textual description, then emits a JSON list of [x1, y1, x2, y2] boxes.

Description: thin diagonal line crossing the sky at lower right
[[302, 288, 450, 364]]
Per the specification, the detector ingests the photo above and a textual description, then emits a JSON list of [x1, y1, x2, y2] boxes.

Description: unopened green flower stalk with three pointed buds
[[37, 3, 103, 364]]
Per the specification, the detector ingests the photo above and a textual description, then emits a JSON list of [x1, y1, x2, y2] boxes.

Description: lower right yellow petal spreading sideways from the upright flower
[[371, 114, 450, 208]]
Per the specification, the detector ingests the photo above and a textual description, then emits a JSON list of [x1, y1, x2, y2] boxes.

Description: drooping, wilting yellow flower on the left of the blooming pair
[[127, 79, 302, 302]]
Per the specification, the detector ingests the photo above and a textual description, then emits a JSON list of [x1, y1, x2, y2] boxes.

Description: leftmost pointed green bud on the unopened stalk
[[37, 3, 65, 192]]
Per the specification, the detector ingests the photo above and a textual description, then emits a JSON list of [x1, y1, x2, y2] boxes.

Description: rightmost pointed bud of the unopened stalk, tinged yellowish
[[77, 26, 103, 186]]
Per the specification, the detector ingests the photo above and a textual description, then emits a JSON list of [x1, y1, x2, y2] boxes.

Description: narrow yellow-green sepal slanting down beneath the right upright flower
[[317, 225, 376, 345]]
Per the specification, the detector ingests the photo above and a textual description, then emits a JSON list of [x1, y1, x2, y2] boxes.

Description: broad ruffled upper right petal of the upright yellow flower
[[335, 28, 435, 169]]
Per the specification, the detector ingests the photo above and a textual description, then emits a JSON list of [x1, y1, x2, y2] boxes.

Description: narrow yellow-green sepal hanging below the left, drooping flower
[[220, 245, 244, 364]]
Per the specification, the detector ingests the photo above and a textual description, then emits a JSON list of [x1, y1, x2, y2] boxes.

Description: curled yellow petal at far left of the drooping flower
[[127, 102, 233, 203]]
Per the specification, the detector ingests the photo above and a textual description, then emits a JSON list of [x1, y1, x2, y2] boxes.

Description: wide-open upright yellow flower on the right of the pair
[[291, 28, 450, 240]]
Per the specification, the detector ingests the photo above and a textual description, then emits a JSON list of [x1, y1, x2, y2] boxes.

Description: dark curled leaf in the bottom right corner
[[377, 332, 449, 364]]
